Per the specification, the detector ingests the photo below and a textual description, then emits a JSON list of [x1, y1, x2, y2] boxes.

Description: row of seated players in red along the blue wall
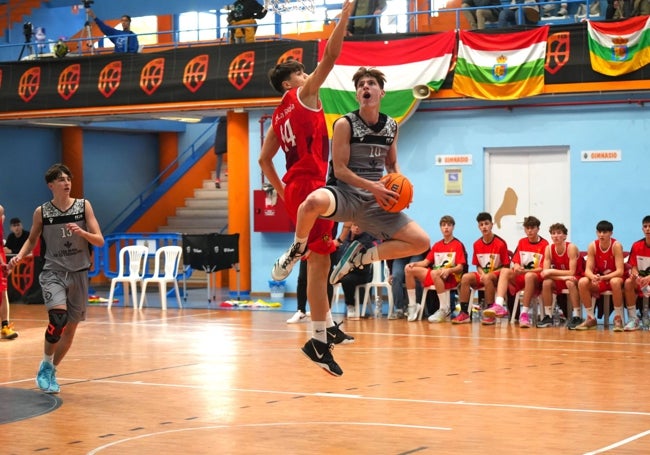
[[334, 212, 650, 331]]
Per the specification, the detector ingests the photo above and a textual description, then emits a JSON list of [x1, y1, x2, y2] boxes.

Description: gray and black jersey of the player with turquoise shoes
[[41, 199, 91, 272]]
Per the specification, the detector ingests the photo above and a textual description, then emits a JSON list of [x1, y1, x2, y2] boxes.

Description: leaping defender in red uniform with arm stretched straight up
[[259, 0, 353, 376]]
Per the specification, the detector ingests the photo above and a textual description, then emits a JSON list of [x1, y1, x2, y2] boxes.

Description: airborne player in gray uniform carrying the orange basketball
[[278, 67, 430, 292]]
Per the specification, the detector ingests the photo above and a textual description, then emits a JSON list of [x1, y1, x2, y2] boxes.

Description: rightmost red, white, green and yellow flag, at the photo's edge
[[587, 16, 650, 76]]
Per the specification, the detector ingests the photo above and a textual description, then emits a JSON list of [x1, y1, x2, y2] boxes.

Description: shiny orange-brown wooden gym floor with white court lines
[[0, 292, 650, 455]]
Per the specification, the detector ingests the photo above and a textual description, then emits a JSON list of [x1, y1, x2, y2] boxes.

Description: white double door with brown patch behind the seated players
[[485, 146, 571, 251]]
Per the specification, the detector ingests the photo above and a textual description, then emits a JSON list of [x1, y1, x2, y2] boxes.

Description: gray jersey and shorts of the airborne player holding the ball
[[325, 111, 411, 240]]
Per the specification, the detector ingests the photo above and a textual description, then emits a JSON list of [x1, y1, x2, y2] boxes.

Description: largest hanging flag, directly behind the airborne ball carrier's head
[[318, 30, 456, 135]]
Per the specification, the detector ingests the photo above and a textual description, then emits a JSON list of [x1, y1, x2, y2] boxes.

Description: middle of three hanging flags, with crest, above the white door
[[452, 25, 549, 100]]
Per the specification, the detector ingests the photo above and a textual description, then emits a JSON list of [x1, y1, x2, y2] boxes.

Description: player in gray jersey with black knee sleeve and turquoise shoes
[[8, 164, 104, 393]]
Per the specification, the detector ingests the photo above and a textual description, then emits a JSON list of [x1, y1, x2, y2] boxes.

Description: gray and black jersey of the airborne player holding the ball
[[334, 111, 397, 199]]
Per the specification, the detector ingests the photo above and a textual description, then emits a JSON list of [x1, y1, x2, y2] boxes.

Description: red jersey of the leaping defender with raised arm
[[272, 87, 329, 186]]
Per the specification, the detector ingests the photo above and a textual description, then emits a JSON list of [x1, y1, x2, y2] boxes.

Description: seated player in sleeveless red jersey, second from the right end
[[576, 220, 625, 332]]
